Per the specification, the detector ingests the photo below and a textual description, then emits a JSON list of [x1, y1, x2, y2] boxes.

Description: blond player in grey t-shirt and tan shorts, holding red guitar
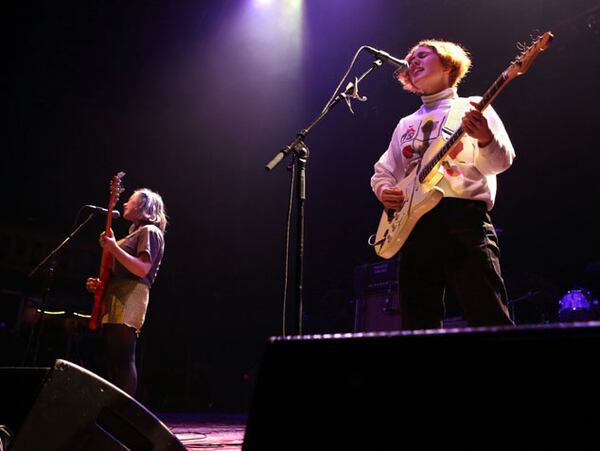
[[86, 188, 167, 396]]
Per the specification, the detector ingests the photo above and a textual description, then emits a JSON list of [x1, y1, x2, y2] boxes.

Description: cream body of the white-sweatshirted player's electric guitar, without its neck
[[374, 164, 444, 258]]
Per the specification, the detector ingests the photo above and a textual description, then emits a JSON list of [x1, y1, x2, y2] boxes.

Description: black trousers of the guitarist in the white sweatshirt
[[399, 198, 513, 330]]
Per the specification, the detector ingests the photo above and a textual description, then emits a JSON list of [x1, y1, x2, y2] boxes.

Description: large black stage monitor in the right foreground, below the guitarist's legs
[[242, 322, 600, 451]]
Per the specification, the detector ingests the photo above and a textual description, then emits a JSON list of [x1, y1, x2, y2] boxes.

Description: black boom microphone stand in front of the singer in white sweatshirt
[[265, 59, 383, 335]]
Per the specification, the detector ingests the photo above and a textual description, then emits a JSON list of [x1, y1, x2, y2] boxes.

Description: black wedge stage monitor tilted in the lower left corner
[[0, 359, 186, 451]]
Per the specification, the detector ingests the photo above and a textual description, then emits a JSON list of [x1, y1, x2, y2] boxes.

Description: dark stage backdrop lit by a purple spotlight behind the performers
[[0, 0, 600, 410]]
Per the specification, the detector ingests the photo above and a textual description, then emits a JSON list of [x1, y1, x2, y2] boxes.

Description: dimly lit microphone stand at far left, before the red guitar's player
[[23, 212, 96, 365]]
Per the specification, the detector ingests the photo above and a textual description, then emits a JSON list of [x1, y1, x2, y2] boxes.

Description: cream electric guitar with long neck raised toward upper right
[[371, 31, 554, 258]]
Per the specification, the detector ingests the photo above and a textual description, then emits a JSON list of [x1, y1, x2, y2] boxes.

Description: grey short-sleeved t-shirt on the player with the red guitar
[[113, 224, 165, 287]]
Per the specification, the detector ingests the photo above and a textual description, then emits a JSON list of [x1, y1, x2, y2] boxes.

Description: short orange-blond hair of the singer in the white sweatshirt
[[396, 39, 472, 93]]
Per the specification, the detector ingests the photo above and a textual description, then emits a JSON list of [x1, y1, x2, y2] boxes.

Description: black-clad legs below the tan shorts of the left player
[[103, 323, 137, 396]]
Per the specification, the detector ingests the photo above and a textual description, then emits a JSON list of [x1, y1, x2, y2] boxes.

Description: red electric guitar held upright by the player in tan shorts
[[88, 172, 125, 330]]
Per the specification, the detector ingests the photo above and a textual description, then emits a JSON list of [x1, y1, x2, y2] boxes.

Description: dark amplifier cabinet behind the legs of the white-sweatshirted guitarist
[[354, 259, 402, 332]]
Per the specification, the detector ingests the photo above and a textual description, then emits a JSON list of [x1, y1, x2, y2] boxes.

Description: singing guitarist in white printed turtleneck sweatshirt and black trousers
[[371, 40, 515, 330]]
